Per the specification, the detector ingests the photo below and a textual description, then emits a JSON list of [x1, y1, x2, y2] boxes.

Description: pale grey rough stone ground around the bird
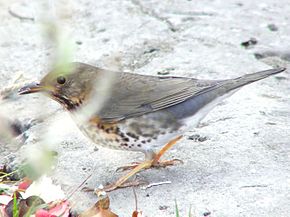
[[0, 0, 290, 217]]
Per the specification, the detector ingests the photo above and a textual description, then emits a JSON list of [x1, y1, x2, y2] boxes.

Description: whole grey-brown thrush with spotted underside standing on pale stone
[[19, 62, 285, 191]]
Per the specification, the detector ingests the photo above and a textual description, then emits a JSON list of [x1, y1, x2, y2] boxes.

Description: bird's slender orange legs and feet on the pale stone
[[103, 136, 182, 192]]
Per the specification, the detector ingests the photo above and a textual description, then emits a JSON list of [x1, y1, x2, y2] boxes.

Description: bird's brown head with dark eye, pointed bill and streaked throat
[[19, 62, 99, 110]]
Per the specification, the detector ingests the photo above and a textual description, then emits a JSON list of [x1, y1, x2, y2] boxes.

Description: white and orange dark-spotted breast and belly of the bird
[[73, 112, 181, 152]]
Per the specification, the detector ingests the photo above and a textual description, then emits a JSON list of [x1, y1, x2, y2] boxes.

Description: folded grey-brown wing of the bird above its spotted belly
[[98, 73, 218, 122]]
